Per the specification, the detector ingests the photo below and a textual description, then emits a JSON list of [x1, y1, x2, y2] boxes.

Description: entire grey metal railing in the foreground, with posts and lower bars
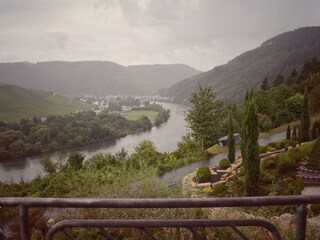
[[0, 195, 320, 240]]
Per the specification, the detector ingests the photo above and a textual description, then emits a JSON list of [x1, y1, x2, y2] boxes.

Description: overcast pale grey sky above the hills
[[0, 0, 320, 71]]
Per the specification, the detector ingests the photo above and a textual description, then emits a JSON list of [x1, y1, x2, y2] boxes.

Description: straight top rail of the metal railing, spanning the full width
[[0, 195, 320, 208]]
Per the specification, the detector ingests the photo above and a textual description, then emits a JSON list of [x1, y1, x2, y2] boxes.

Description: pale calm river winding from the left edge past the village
[[0, 103, 187, 181]]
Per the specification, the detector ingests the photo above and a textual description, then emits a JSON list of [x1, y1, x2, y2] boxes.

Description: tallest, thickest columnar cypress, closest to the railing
[[245, 98, 260, 196]]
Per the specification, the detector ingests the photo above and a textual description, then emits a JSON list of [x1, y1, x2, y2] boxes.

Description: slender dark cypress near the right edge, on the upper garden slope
[[299, 88, 310, 142]]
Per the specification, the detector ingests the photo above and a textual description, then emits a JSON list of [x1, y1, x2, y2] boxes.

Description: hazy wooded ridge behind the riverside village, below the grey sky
[[0, 61, 199, 96]]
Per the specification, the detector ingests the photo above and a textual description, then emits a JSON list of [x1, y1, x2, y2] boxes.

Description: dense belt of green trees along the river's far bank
[[0, 104, 169, 159]]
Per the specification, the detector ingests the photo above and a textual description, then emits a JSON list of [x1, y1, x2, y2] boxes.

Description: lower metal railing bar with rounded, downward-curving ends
[[45, 219, 281, 240]]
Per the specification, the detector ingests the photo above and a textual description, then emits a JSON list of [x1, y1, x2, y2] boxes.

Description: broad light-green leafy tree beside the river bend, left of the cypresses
[[186, 85, 225, 150]]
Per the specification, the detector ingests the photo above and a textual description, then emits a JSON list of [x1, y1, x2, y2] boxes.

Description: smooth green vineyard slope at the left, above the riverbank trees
[[0, 84, 92, 121]]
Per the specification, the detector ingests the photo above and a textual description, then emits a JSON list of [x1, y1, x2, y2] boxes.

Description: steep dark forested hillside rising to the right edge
[[159, 27, 320, 103]]
